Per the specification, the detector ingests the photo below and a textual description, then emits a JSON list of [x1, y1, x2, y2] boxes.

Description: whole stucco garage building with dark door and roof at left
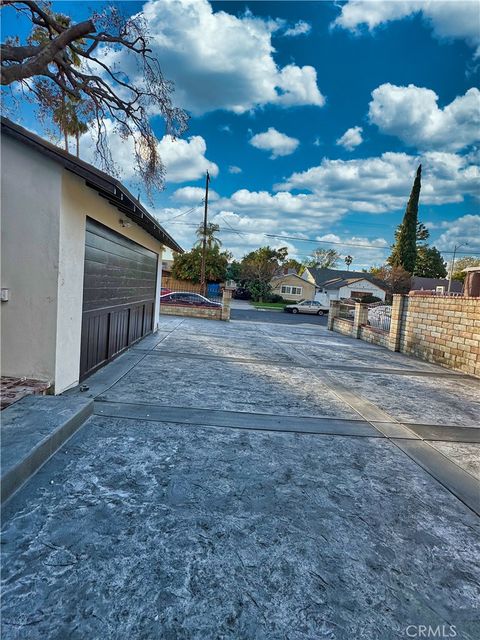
[[1, 119, 182, 393]]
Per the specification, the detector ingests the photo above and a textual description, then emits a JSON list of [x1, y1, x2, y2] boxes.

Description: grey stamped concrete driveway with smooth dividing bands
[[2, 318, 480, 640]]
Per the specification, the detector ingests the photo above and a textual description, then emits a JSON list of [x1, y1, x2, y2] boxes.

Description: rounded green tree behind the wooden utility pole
[[172, 246, 232, 284]]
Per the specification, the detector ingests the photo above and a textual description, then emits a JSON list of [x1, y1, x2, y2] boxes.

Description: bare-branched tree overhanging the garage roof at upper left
[[0, 0, 188, 192]]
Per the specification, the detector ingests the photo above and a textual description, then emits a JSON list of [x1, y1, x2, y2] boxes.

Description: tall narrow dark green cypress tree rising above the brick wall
[[388, 165, 422, 273]]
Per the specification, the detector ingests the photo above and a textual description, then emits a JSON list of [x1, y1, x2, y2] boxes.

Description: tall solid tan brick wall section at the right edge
[[399, 295, 480, 376]]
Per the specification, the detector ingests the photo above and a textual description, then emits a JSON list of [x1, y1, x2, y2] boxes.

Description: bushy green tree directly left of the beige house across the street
[[240, 247, 288, 302]]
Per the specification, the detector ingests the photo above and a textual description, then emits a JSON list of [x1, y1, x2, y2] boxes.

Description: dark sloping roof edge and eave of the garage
[[2, 117, 183, 253]]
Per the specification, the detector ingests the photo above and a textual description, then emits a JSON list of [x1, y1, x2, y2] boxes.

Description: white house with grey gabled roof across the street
[[302, 267, 387, 304]]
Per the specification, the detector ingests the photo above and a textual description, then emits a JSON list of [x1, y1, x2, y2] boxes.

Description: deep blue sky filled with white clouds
[[2, 0, 480, 269]]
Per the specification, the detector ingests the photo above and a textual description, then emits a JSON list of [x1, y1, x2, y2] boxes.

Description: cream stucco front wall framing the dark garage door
[[55, 170, 162, 393]]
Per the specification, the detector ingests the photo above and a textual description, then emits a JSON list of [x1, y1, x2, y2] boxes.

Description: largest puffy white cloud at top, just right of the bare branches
[[114, 0, 325, 115]]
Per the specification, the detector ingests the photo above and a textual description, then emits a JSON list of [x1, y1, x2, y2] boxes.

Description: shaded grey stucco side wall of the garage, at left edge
[[0, 136, 62, 381]]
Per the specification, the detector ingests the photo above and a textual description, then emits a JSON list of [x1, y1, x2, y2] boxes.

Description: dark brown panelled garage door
[[80, 218, 157, 378]]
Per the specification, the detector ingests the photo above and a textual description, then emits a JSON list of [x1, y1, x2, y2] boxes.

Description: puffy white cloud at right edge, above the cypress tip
[[369, 83, 480, 151]]
